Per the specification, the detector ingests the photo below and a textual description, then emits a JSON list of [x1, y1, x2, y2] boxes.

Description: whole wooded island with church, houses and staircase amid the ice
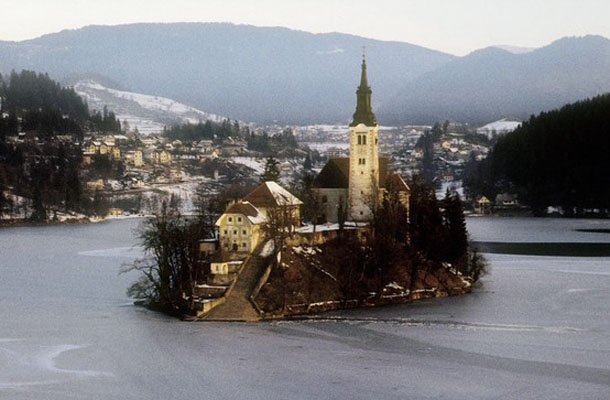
[[127, 58, 485, 321]]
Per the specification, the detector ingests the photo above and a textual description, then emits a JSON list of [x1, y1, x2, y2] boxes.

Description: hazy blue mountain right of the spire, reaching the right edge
[[377, 36, 610, 124]]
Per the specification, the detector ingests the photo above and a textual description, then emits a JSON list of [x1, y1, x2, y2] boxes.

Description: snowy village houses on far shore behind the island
[[0, 110, 525, 222]]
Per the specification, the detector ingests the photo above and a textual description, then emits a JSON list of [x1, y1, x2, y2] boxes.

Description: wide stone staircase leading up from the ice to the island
[[203, 252, 269, 321]]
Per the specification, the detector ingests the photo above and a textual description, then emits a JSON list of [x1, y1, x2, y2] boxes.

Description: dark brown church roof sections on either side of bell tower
[[313, 157, 400, 191]]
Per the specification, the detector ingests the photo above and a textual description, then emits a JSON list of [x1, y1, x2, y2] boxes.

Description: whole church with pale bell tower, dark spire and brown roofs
[[313, 55, 410, 222]]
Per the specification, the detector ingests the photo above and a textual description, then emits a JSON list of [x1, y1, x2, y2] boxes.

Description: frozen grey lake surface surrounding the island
[[0, 218, 610, 400]]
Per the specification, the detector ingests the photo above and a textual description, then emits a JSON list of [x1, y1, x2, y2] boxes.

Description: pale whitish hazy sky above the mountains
[[0, 0, 610, 55]]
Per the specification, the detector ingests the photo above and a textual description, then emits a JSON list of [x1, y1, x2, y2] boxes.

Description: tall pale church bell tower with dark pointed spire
[[347, 53, 379, 222]]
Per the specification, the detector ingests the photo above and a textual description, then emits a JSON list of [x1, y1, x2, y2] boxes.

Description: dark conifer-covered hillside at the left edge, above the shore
[[0, 71, 121, 221]]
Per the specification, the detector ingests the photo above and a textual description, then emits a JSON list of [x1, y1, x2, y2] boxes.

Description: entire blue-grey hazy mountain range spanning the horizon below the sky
[[0, 22, 610, 125]]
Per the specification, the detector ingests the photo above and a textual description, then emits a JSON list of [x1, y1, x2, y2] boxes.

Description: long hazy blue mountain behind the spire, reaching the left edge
[[0, 23, 455, 124]]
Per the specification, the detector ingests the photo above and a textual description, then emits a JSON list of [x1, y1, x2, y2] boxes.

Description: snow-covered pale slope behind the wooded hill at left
[[71, 78, 226, 135]]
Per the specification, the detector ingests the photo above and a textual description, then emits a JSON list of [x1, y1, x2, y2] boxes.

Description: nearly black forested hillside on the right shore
[[464, 94, 610, 216]]
